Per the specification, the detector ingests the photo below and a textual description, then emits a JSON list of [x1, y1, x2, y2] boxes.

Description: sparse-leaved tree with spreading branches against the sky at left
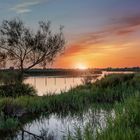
[[0, 18, 65, 73]]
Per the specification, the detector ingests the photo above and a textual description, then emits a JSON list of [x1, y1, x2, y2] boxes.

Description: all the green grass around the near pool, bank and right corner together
[[0, 74, 140, 140]]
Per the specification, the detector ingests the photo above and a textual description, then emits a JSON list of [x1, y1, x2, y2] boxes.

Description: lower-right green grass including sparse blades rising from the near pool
[[67, 92, 140, 140]]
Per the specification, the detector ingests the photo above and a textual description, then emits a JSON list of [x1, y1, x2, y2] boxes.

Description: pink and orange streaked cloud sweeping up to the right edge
[[66, 14, 140, 56]]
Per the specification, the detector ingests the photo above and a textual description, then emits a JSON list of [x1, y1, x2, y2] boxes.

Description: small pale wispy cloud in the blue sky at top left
[[11, 0, 42, 13]]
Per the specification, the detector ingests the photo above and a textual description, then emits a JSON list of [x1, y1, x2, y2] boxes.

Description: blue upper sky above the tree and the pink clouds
[[0, 0, 140, 34]]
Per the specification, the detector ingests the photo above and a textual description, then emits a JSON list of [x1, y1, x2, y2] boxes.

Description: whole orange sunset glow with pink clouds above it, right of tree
[[53, 18, 140, 69]]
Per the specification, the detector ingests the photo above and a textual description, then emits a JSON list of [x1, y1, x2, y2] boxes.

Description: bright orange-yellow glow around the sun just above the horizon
[[54, 37, 140, 69]]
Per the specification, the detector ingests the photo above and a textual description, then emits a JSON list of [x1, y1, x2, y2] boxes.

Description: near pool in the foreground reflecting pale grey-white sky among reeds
[[13, 108, 114, 140]]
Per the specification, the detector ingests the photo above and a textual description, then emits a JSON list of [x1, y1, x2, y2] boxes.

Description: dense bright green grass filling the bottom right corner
[[97, 93, 140, 140]]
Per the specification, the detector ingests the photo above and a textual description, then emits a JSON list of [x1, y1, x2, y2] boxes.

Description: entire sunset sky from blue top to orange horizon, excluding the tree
[[0, 0, 140, 68]]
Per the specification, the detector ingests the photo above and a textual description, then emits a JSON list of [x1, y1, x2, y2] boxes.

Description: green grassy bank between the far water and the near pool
[[0, 74, 140, 138]]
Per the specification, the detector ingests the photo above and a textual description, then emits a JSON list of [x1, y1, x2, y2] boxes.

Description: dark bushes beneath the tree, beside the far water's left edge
[[0, 71, 36, 98]]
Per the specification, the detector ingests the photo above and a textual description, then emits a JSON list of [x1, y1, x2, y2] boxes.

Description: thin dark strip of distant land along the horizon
[[0, 67, 140, 76]]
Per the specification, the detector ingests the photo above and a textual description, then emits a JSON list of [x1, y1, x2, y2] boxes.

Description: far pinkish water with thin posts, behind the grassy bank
[[24, 71, 133, 96]]
